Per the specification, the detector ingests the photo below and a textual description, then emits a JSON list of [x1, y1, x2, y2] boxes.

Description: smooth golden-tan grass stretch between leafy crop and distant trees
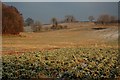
[[3, 24, 117, 53]]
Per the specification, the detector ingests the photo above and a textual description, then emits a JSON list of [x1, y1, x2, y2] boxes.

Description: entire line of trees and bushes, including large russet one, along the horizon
[[2, 4, 118, 34]]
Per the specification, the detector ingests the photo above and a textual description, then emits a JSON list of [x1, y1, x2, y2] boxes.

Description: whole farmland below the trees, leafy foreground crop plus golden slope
[[2, 23, 119, 80]]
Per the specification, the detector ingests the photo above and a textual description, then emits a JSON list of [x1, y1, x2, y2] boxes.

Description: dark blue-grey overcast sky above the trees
[[6, 2, 118, 23]]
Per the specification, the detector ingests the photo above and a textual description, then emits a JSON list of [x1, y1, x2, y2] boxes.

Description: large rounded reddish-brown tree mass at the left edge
[[2, 4, 23, 34]]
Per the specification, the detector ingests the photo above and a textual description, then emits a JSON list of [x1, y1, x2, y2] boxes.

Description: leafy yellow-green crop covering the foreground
[[3, 48, 119, 80]]
